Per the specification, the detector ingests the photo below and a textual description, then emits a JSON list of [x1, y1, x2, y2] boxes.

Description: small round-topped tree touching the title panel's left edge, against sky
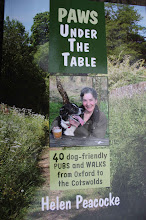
[[31, 12, 50, 47]]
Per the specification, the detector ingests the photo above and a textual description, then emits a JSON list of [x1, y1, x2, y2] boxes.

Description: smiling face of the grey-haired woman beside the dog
[[83, 93, 97, 113]]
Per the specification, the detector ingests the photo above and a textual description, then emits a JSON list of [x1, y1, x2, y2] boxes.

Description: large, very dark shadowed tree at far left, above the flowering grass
[[0, 17, 48, 113]]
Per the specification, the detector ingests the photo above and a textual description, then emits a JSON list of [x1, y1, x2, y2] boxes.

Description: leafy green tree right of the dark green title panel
[[105, 4, 146, 59]]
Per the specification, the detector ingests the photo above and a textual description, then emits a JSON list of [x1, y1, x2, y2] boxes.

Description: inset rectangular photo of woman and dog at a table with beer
[[49, 76, 109, 147]]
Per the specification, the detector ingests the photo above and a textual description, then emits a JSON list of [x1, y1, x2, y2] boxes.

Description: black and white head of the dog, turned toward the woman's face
[[60, 103, 83, 121]]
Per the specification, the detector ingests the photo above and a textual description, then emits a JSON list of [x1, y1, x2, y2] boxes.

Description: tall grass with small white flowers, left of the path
[[0, 104, 48, 220]]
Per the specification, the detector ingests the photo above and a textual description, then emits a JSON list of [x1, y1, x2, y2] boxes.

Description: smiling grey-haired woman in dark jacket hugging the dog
[[70, 87, 107, 138]]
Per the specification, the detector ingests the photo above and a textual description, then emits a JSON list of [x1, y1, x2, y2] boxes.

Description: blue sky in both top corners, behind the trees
[[4, 0, 146, 36]]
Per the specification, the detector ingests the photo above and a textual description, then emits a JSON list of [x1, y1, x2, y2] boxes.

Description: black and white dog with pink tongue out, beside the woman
[[58, 103, 84, 136]]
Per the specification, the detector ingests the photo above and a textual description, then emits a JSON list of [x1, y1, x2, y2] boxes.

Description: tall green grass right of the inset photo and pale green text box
[[109, 95, 146, 196]]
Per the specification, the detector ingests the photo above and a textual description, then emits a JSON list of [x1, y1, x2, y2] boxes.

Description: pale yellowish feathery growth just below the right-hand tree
[[108, 55, 146, 90]]
